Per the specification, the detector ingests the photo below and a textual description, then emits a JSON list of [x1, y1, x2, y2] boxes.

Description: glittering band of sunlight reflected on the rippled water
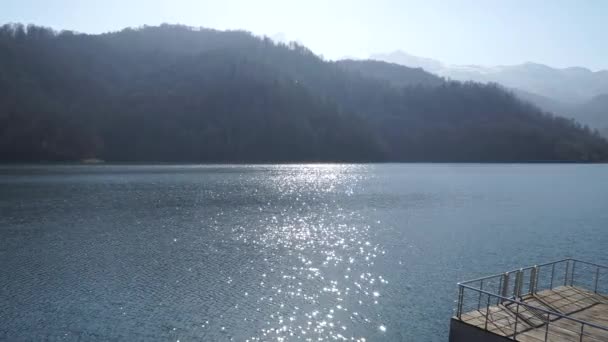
[[230, 165, 386, 340]]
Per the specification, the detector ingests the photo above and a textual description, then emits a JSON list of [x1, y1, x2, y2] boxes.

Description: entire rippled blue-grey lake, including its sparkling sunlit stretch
[[0, 164, 608, 341]]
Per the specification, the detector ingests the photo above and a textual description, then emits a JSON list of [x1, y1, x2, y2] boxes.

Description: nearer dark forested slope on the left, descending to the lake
[[0, 24, 384, 162]]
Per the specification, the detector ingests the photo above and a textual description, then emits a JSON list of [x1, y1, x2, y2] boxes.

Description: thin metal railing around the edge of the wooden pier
[[455, 258, 608, 341]]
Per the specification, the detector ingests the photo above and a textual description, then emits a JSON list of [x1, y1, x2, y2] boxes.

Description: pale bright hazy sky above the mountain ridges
[[0, 0, 608, 70]]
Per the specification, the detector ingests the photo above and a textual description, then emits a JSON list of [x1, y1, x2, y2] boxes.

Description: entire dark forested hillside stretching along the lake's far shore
[[0, 25, 608, 162]]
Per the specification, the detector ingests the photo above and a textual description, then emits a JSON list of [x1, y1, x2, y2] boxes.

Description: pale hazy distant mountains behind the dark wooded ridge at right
[[370, 51, 608, 138]]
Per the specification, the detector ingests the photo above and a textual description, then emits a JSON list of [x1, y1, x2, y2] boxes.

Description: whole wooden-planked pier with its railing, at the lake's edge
[[450, 259, 608, 342]]
